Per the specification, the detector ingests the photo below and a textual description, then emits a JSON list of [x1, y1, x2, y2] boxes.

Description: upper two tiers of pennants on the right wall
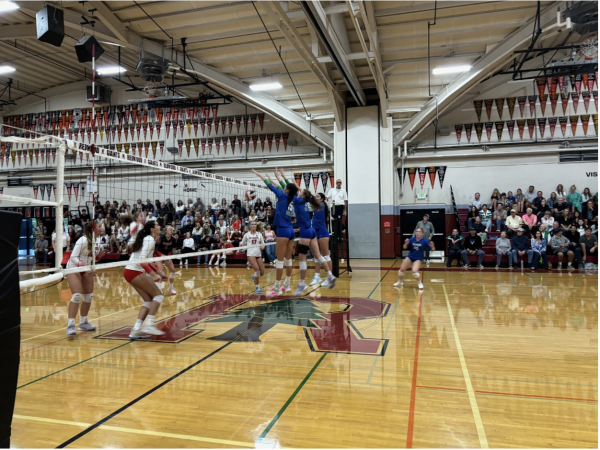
[[473, 73, 598, 122]]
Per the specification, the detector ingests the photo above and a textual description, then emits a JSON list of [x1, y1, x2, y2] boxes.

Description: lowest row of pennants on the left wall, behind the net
[[0, 133, 289, 167]]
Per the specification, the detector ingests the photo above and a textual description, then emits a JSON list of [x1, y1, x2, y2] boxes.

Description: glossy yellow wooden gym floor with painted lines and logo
[[12, 260, 598, 448]]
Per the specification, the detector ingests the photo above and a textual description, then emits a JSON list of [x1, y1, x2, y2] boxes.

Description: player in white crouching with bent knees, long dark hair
[[123, 221, 167, 339]]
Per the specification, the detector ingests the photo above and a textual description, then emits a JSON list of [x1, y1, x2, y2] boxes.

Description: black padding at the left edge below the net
[[0, 211, 22, 448]]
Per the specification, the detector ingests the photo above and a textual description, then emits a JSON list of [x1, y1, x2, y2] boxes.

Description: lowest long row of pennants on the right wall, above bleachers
[[454, 114, 598, 143]]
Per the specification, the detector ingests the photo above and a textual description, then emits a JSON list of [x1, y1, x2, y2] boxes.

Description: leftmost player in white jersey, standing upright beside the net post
[[67, 221, 107, 336]]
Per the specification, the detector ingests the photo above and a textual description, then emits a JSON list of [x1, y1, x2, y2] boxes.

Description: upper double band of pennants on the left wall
[[3, 103, 265, 143]]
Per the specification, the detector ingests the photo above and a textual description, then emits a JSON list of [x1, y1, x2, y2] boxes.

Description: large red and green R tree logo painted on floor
[[97, 294, 391, 356]]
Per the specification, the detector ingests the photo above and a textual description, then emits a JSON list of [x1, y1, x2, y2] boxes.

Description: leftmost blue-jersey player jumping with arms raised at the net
[[252, 170, 298, 296]]
